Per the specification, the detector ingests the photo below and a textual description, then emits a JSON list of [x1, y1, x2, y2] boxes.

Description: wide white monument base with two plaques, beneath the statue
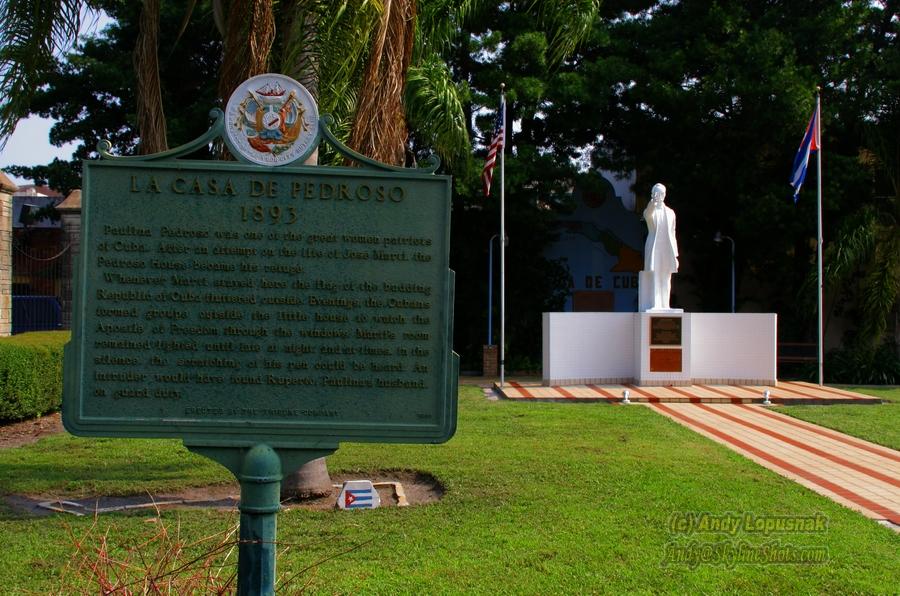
[[543, 309, 777, 385]]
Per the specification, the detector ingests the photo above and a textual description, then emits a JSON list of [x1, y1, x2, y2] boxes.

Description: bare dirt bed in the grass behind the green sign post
[[3, 470, 444, 516]]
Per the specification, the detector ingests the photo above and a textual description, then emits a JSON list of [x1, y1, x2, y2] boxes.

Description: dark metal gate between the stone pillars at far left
[[12, 239, 69, 334]]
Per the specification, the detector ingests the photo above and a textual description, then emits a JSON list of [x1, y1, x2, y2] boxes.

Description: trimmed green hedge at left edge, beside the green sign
[[0, 331, 70, 422]]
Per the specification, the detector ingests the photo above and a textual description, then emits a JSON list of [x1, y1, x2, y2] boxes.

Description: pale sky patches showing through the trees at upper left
[[0, 13, 110, 185]]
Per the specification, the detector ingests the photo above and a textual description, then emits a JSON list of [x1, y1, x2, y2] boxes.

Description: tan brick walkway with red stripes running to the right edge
[[647, 403, 900, 529]]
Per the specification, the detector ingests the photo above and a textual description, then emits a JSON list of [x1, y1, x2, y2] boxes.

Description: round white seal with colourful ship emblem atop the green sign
[[225, 74, 319, 166]]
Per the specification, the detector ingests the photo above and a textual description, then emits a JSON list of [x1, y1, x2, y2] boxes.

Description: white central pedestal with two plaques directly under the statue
[[634, 309, 692, 386]]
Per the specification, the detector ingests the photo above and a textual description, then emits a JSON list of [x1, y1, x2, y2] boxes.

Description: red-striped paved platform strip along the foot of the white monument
[[494, 381, 881, 404]]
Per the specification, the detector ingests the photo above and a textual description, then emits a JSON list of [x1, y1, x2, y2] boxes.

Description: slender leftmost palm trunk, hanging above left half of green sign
[[132, 0, 169, 155]]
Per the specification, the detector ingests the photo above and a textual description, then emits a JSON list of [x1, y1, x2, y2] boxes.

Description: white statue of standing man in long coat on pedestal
[[641, 184, 678, 310]]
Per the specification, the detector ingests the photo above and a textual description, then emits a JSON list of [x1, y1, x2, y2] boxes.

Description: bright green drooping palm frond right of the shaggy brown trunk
[[404, 54, 469, 163]]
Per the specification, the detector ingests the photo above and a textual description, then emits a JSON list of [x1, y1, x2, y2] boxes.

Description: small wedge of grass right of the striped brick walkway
[[778, 387, 900, 449]]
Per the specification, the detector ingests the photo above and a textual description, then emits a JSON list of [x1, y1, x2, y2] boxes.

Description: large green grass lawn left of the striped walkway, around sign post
[[0, 387, 900, 594]]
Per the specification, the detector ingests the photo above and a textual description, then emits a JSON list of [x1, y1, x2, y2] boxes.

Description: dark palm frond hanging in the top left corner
[[0, 0, 86, 149]]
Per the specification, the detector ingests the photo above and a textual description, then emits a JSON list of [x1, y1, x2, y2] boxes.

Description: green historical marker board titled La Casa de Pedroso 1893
[[65, 154, 457, 446]]
